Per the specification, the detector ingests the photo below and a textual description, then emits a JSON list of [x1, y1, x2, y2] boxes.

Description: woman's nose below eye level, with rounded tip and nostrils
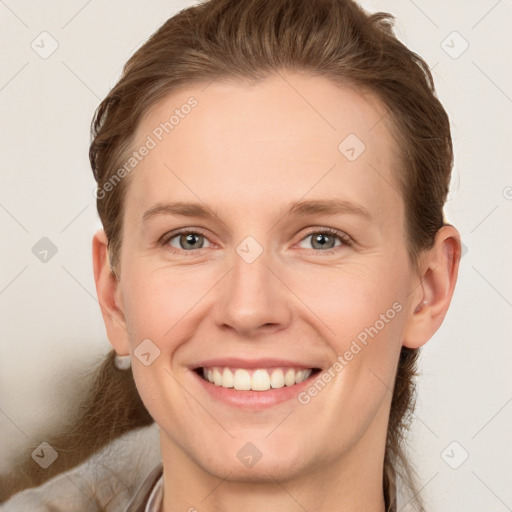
[[212, 245, 293, 338]]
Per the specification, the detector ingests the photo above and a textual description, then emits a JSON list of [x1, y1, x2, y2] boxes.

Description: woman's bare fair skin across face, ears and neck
[[93, 73, 460, 512]]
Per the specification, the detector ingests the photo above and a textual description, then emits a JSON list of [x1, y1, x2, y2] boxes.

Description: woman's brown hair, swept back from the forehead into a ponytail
[[3, 0, 453, 509]]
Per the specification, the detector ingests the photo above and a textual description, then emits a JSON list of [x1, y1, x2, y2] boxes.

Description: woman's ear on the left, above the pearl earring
[[92, 229, 130, 355]]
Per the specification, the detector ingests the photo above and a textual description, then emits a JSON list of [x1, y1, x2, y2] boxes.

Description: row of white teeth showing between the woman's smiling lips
[[194, 366, 320, 391]]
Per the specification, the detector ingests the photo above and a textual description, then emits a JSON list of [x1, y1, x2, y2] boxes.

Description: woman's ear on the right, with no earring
[[402, 224, 461, 348]]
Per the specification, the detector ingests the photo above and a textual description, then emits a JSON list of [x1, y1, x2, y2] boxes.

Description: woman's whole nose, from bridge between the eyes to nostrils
[[217, 236, 291, 335]]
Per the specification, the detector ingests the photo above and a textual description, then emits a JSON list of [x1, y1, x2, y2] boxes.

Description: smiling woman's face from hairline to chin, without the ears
[[107, 73, 419, 480]]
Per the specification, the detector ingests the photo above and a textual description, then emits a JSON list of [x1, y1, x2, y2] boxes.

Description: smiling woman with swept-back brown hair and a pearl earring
[[2, 0, 460, 512]]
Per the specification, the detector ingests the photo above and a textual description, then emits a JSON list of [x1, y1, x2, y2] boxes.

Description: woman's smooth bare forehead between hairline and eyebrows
[[127, 73, 401, 226]]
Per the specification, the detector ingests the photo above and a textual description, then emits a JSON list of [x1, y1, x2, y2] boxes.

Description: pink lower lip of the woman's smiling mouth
[[192, 371, 319, 410]]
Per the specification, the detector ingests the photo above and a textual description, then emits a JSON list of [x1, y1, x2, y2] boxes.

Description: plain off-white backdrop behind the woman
[[0, 0, 512, 512]]
